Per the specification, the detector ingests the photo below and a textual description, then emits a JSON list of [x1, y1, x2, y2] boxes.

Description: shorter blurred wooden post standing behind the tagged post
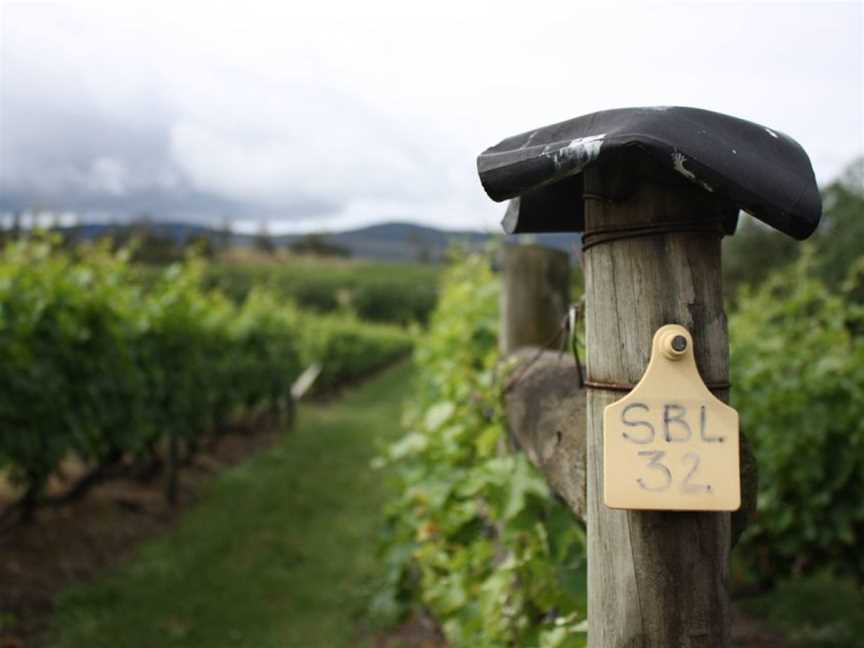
[[500, 245, 570, 355]]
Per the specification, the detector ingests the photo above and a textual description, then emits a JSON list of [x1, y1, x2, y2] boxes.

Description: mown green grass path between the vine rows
[[48, 365, 411, 648]]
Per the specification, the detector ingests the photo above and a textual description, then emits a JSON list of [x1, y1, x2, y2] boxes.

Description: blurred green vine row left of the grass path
[[0, 237, 412, 508]]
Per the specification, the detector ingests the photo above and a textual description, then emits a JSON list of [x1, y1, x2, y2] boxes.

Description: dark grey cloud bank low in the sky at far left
[[0, 32, 343, 221]]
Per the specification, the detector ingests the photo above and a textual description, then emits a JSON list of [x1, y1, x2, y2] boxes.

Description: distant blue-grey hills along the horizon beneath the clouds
[[55, 222, 579, 261]]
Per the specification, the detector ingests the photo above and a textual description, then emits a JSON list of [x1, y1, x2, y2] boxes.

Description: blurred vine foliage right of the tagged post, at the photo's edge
[[730, 248, 864, 583]]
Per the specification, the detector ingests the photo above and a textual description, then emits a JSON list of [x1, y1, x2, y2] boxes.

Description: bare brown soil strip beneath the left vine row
[[0, 422, 279, 648]]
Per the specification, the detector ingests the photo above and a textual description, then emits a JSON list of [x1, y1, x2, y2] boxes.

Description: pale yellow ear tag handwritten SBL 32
[[603, 324, 741, 511]]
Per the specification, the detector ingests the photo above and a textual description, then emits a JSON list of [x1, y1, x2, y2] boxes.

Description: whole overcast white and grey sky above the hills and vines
[[0, 0, 864, 231]]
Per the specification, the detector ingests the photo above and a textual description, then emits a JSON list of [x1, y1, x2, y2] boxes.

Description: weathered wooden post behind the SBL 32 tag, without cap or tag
[[583, 167, 730, 648]]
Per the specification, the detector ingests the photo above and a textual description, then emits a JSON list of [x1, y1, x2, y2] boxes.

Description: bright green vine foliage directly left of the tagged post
[[373, 254, 585, 648]]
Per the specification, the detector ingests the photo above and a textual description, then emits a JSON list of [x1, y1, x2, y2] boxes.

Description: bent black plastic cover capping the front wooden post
[[477, 106, 822, 240]]
